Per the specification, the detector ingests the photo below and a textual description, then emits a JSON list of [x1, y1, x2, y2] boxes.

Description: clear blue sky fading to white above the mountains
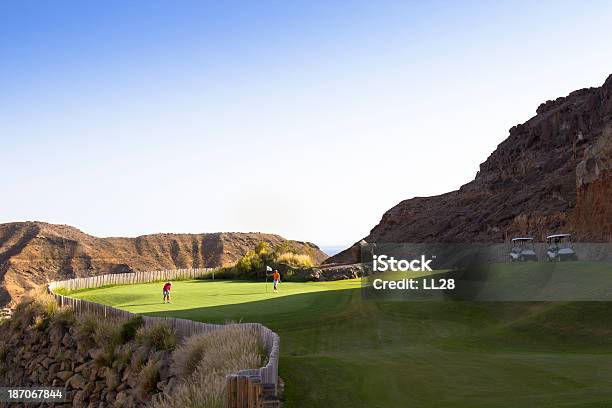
[[0, 0, 612, 245]]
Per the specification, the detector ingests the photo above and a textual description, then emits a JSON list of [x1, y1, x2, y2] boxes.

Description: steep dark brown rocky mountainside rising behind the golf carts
[[326, 75, 612, 263]]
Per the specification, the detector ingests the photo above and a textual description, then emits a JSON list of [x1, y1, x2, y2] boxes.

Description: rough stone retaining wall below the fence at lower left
[[0, 310, 177, 408]]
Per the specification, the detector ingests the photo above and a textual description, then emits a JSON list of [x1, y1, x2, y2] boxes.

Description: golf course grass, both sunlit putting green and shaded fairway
[[71, 280, 612, 408]]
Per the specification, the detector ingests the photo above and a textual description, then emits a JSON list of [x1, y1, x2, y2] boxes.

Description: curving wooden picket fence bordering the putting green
[[48, 268, 280, 408]]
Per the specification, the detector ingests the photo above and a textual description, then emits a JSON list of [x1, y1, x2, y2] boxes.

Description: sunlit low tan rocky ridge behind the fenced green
[[0, 222, 327, 305]]
